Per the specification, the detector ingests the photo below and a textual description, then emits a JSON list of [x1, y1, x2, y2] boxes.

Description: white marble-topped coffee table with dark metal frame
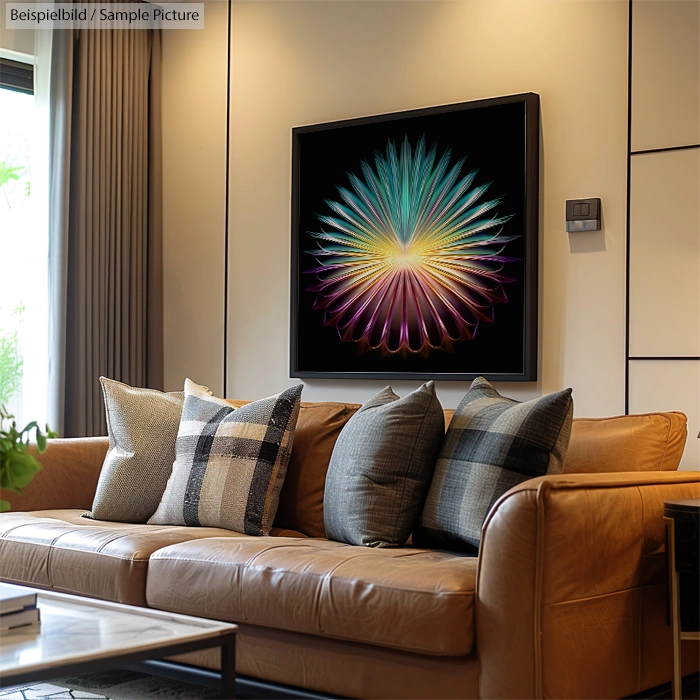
[[0, 591, 238, 700]]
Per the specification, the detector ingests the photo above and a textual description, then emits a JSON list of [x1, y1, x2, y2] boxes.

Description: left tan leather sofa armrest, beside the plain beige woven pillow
[[0, 437, 109, 511]]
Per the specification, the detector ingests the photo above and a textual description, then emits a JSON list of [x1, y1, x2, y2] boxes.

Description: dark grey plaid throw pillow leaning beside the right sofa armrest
[[413, 377, 574, 552]]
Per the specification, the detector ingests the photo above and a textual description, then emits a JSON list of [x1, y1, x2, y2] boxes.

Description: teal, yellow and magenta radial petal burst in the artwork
[[307, 138, 517, 354]]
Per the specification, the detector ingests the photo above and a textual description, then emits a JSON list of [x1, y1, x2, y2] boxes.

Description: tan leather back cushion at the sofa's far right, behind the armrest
[[564, 411, 688, 474]]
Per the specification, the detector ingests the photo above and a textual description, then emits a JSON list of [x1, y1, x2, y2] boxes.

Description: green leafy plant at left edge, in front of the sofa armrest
[[0, 406, 57, 512]]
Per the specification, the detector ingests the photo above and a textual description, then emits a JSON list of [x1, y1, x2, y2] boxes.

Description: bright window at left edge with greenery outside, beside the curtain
[[0, 57, 48, 423]]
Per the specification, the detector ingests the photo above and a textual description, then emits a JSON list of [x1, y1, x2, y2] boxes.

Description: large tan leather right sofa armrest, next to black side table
[[476, 471, 700, 700]]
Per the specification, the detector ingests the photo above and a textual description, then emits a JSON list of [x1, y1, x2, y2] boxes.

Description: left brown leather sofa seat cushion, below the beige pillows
[[0, 510, 303, 605]]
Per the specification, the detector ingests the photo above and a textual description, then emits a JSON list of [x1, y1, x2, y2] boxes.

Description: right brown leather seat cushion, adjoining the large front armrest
[[146, 537, 477, 656]]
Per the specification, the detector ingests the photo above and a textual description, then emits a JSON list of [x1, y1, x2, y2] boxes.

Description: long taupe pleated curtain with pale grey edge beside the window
[[49, 24, 163, 437]]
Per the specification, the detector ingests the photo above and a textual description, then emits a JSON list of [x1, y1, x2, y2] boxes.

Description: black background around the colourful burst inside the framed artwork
[[292, 102, 526, 375]]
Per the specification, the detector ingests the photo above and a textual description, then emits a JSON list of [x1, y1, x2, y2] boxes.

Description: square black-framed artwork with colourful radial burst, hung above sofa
[[290, 93, 539, 381]]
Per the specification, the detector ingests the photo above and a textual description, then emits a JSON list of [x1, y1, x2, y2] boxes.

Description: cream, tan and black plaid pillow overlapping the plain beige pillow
[[148, 379, 303, 535]]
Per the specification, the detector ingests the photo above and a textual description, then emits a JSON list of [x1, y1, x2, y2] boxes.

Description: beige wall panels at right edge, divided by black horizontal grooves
[[625, 0, 700, 456]]
